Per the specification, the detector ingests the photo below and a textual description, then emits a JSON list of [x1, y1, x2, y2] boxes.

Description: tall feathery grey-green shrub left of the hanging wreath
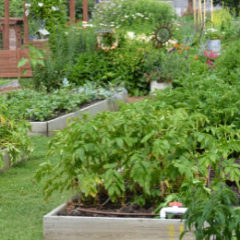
[[33, 25, 96, 91]]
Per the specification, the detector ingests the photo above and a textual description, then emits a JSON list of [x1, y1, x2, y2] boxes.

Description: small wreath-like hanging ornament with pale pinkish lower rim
[[97, 30, 118, 52]]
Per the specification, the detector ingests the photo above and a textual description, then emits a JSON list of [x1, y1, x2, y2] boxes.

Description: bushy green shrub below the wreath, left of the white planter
[[66, 41, 149, 95]]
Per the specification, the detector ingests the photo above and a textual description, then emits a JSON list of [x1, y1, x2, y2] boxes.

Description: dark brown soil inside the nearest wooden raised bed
[[58, 201, 159, 218]]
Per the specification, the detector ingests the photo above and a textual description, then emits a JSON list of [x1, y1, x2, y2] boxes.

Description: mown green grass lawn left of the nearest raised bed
[[0, 137, 68, 240]]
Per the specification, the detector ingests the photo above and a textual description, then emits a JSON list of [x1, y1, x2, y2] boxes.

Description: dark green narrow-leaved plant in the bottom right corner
[[181, 183, 240, 240]]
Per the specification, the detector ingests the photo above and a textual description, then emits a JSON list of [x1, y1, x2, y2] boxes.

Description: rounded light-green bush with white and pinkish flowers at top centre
[[93, 0, 174, 33]]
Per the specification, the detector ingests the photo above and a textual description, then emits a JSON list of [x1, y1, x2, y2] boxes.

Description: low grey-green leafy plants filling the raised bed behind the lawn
[[0, 83, 118, 121]]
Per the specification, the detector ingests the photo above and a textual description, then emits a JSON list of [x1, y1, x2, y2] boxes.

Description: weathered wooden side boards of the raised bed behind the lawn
[[30, 92, 128, 136]]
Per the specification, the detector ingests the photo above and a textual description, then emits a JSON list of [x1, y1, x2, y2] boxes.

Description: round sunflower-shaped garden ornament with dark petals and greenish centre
[[152, 25, 172, 48]]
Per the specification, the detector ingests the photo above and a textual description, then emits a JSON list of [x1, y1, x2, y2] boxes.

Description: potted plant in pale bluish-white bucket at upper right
[[205, 28, 224, 53]]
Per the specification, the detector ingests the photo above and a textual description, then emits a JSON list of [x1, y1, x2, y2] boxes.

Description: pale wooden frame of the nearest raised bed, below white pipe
[[43, 204, 195, 240]]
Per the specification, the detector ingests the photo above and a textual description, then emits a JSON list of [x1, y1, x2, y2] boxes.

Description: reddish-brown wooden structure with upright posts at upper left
[[0, 0, 88, 78]]
